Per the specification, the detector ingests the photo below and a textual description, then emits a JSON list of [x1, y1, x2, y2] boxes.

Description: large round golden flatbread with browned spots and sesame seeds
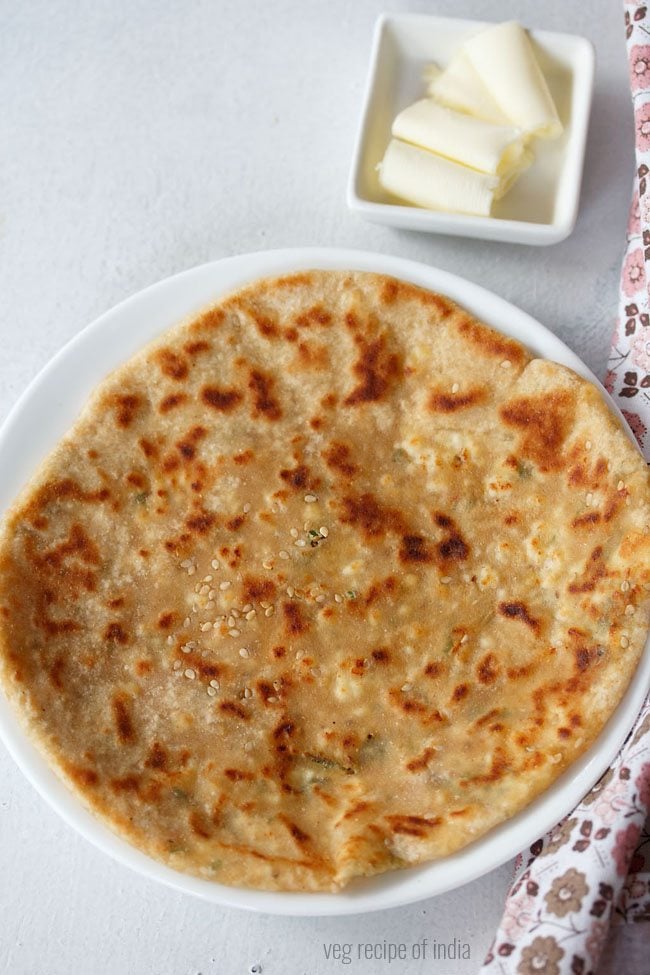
[[0, 271, 650, 891]]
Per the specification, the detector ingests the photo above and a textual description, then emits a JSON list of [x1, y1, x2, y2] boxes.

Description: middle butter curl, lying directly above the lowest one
[[392, 98, 533, 184]]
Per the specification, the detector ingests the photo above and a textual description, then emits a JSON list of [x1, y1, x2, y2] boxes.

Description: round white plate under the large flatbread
[[0, 248, 650, 915]]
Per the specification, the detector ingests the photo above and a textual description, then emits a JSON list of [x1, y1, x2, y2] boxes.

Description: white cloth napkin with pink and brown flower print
[[480, 2, 650, 975]]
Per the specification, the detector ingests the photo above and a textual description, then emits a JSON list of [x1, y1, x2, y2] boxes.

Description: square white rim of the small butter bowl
[[346, 12, 596, 246]]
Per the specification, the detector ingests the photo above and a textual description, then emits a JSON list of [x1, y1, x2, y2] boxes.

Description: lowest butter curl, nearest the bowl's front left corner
[[377, 139, 500, 217]]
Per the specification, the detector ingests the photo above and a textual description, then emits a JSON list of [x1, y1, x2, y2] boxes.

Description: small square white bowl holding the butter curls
[[347, 14, 594, 244]]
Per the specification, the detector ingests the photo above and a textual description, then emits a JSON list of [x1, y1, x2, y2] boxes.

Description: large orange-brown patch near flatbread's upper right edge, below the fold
[[499, 389, 575, 473]]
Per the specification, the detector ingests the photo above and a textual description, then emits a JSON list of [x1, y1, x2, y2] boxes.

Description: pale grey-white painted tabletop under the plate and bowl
[[0, 0, 633, 975]]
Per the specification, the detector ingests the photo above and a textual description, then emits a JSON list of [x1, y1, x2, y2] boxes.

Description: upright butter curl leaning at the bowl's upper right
[[463, 21, 562, 139]]
